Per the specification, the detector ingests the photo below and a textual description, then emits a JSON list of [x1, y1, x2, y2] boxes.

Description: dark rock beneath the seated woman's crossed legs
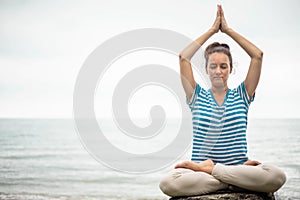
[[170, 190, 275, 200]]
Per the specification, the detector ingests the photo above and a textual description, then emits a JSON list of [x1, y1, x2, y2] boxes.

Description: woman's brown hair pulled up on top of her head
[[204, 42, 233, 72]]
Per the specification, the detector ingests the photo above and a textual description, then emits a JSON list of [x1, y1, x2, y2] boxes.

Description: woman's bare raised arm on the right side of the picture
[[220, 7, 263, 99]]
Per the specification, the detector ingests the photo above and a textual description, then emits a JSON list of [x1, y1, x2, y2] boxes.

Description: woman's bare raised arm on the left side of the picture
[[179, 6, 221, 99]]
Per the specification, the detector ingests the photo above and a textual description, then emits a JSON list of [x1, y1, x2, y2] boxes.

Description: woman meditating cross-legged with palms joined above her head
[[160, 6, 286, 197]]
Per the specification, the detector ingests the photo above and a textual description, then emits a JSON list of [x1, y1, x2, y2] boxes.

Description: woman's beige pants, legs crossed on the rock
[[159, 164, 286, 197]]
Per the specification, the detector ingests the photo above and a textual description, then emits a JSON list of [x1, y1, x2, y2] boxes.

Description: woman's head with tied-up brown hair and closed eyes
[[204, 42, 233, 87]]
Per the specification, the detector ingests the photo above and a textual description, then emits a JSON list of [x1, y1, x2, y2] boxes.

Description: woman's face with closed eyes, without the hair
[[206, 52, 230, 88]]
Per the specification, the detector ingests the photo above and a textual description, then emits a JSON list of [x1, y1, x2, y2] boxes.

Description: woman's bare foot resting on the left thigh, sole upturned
[[175, 159, 215, 174]]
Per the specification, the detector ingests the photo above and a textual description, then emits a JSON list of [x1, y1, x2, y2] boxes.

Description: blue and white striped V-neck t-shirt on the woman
[[187, 82, 254, 165]]
